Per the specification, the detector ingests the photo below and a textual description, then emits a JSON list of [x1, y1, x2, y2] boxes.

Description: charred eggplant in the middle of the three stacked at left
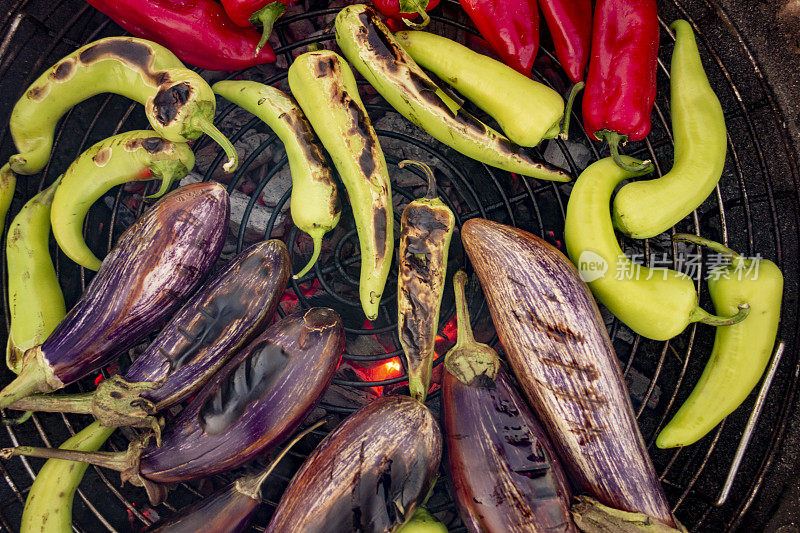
[[11, 240, 291, 429]]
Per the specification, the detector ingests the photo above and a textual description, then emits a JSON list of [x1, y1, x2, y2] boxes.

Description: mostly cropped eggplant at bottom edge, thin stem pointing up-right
[[147, 420, 325, 533]]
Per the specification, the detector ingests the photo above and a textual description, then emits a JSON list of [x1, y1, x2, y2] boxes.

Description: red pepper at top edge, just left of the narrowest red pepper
[[459, 0, 539, 76]]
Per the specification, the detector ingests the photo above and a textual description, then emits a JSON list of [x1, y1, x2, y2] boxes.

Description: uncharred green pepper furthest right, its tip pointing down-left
[[656, 234, 783, 448]]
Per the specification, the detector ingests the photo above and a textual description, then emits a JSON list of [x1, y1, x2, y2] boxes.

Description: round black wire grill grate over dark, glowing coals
[[0, 0, 800, 532]]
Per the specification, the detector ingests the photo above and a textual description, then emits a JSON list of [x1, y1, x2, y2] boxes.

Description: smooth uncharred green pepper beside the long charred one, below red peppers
[[394, 31, 565, 146]]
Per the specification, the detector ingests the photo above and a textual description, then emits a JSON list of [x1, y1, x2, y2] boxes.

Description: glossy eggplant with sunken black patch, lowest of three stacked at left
[[0, 307, 344, 503]]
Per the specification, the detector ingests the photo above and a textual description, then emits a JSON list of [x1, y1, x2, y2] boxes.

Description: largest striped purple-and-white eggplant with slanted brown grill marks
[[461, 218, 675, 526]]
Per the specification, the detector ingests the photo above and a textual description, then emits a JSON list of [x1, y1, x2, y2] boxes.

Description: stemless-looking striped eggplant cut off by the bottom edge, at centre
[[266, 396, 442, 533]]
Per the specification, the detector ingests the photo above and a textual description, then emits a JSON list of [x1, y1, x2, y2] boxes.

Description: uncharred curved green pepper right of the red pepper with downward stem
[[614, 20, 728, 239]]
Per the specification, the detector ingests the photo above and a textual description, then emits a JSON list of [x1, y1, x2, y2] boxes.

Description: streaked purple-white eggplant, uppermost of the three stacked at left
[[0, 182, 230, 408]]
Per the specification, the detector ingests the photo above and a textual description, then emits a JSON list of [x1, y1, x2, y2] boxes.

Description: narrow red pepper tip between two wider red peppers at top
[[539, 0, 592, 83]]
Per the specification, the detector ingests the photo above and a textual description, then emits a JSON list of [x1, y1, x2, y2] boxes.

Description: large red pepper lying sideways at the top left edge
[[87, 0, 275, 71]]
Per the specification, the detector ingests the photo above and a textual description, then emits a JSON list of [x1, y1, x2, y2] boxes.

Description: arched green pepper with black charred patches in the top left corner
[[9, 37, 238, 174]]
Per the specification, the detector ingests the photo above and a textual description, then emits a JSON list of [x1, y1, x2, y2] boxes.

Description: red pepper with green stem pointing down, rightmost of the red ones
[[583, 0, 659, 171]]
